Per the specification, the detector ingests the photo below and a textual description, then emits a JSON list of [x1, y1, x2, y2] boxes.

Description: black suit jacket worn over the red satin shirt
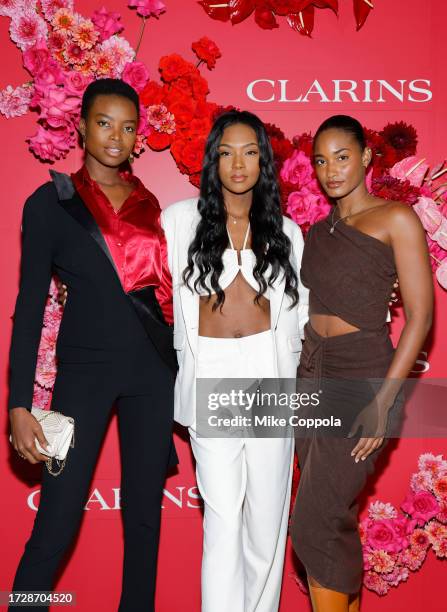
[[8, 173, 176, 410]]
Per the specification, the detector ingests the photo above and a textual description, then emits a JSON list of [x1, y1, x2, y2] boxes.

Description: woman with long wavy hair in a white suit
[[162, 111, 308, 612]]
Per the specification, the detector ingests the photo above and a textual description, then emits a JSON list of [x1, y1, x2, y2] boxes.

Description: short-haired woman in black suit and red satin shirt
[[9, 79, 175, 612]]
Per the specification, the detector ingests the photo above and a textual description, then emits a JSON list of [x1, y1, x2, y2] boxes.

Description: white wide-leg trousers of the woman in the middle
[[190, 331, 293, 612]]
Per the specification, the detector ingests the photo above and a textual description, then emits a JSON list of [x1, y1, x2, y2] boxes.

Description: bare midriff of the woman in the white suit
[[199, 273, 270, 338]]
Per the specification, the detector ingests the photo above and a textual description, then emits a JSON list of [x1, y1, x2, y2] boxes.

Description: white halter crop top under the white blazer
[[199, 223, 271, 300]]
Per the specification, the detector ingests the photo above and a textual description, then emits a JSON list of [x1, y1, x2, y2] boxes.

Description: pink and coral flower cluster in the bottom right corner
[[359, 453, 447, 595]]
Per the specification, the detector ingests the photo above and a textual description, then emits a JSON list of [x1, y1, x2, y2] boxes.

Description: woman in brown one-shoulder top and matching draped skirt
[[291, 115, 433, 612]]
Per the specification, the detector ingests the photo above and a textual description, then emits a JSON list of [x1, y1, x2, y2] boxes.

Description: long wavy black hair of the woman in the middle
[[183, 110, 298, 310]]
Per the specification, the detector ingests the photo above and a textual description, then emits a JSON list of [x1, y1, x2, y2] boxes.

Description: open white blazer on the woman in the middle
[[161, 198, 309, 427]]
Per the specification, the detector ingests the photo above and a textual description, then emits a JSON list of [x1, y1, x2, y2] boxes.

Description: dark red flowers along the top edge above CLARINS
[[199, 0, 374, 37]]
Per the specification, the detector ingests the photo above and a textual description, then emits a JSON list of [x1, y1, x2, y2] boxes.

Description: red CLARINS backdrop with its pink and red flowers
[[0, 0, 447, 612]]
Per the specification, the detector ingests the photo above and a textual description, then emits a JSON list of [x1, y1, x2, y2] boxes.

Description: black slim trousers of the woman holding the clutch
[[9, 338, 174, 612]]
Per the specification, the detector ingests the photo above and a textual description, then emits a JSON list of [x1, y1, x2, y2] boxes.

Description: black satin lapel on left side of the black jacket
[[50, 170, 118, 276]]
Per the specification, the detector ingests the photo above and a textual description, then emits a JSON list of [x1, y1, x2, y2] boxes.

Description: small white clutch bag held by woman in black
[[9, 408, 74, 476]]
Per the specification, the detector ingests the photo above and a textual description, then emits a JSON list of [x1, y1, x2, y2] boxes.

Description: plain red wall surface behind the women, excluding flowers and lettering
[[0, 0, 447, 612]]
